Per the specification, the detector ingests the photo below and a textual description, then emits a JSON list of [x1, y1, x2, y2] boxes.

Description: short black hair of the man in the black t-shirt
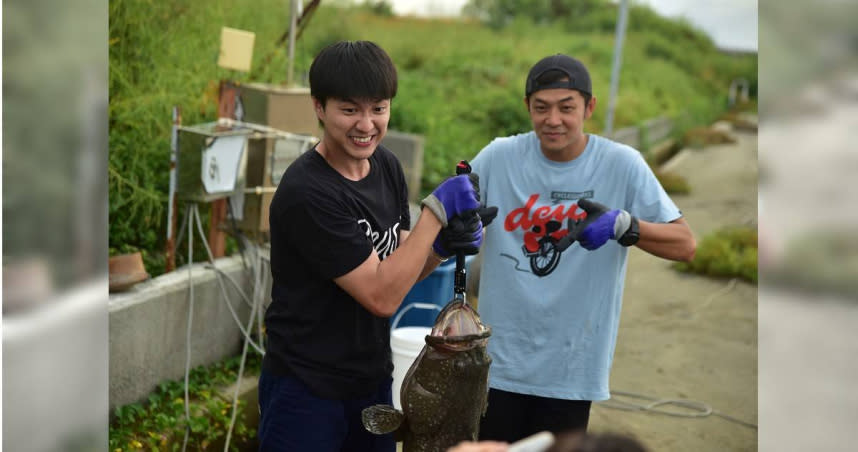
[[310, 41, 397, 106]]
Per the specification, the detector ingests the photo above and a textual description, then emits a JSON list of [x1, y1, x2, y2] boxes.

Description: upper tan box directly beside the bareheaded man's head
[[239, 83, 321, 136]]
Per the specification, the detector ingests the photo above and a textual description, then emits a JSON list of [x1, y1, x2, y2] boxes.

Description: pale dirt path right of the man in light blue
[[590, 125, 758, 451]]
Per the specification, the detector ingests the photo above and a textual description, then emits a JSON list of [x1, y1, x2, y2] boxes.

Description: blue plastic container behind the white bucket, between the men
[[390, 256, 474, 328]]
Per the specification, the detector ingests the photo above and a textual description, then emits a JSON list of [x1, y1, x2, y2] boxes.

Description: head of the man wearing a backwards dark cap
[[524, 54, 596, 161]]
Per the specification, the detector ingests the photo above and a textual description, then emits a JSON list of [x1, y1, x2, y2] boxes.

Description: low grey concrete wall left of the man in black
[[108, 256, 270, 411]]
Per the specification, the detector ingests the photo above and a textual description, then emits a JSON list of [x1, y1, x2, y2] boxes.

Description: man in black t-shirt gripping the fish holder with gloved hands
[[259, 41, 489, 452]]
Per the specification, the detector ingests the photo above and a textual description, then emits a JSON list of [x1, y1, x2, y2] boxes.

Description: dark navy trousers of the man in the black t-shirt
[[259, 371, 396, 452]]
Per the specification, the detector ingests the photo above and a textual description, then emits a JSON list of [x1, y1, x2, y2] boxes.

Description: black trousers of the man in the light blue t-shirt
[[480, 389, 592, 443]]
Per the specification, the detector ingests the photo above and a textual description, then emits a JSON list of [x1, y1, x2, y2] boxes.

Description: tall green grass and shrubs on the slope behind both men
[[109, 0, 757, 275]]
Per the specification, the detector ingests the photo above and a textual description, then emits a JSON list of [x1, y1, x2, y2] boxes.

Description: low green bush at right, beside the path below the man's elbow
[[673, 226, 757, 283]]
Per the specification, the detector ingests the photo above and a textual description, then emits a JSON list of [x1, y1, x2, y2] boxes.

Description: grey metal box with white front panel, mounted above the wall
[[176, 122, 253, 202]]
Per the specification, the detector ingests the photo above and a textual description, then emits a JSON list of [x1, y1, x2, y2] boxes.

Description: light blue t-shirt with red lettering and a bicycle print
[[471, 132, 682, 400]]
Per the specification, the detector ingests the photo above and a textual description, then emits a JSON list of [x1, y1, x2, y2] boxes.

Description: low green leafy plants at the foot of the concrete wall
[[109, 353, 262, 452]]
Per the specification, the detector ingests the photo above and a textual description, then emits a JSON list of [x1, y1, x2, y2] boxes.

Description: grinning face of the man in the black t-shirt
[[313, 98, 390, 165]]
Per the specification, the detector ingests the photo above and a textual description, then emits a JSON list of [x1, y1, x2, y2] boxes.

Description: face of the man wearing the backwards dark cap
[[524, 88, 596, 162]]
